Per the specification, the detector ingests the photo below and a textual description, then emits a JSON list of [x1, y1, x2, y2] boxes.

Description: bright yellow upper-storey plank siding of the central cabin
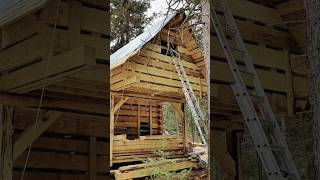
[[111, 38, 207, 99]]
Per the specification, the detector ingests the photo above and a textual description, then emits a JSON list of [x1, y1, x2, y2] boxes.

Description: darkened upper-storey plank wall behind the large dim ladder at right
[[210, 0, 308, 112]]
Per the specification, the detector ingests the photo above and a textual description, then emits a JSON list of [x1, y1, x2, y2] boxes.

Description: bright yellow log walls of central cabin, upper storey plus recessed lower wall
[[110, 16, 208, 138]]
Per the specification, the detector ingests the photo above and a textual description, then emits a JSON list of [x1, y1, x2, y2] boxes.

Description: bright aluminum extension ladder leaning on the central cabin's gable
[[168, 46, 209, 145]]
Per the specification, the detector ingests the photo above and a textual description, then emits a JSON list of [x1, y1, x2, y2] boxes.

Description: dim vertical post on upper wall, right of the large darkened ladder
[[284, 50, 294, 116]]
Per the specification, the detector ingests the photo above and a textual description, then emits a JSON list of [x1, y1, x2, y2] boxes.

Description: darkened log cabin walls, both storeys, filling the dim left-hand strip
[[0, 0, 109, 180]]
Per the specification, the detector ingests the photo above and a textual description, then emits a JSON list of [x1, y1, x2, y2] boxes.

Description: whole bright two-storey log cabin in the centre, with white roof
[[110, 13, 208, 179]]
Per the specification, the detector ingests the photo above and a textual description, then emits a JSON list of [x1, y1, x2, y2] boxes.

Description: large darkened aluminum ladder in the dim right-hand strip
[[210, 0, 300, 180]]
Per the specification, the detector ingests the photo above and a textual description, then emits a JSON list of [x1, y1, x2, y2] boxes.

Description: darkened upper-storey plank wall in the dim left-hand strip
[[0, 0, 109, 97]]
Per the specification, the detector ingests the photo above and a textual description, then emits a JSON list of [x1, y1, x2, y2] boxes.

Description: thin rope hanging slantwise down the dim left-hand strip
[[20, 0, 61, 180]]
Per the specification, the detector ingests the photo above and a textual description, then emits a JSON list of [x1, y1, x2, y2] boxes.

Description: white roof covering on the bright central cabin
[[110, 14, 176, 69]]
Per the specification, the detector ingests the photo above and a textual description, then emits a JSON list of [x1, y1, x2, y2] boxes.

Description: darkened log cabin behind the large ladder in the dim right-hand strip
[[210, 0, 309, 180]]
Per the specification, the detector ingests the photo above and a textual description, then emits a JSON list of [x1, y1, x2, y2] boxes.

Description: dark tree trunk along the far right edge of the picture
[[305, 0, 320, 180]]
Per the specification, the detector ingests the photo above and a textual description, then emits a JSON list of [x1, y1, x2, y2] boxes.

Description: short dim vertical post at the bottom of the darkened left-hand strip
[[89, 136, 97, 180]]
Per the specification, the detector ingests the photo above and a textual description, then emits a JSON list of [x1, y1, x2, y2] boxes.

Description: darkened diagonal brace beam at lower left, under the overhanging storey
[[13, 111, 61, 160]]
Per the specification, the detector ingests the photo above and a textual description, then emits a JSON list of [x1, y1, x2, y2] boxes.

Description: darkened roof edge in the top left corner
[[0, 0, 48, 27]]
